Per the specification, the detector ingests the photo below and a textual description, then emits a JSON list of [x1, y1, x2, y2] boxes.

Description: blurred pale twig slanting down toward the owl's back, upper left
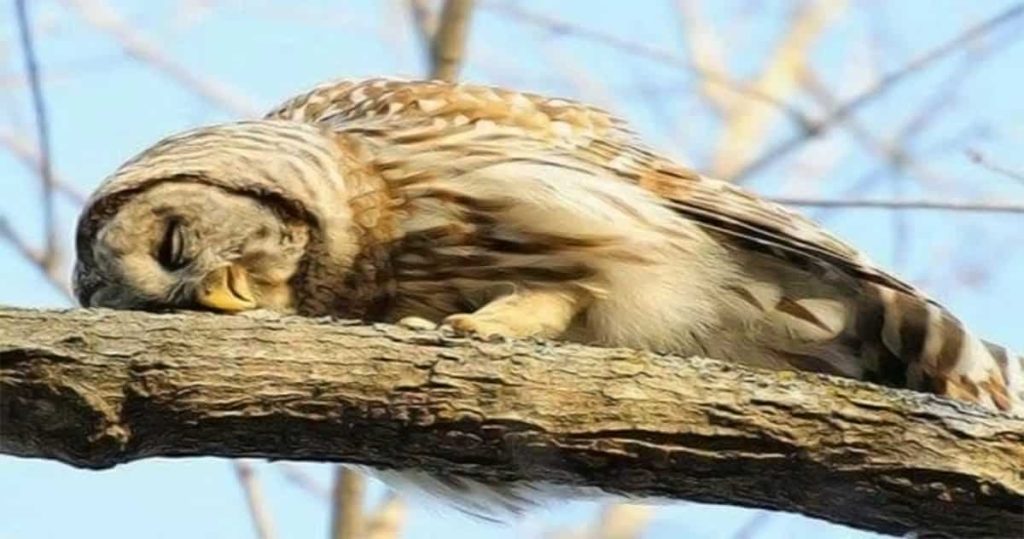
[[65, 0, 261, 118]]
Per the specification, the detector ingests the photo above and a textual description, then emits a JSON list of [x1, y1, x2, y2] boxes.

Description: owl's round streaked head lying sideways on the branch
[[74, 121, 355, 312]]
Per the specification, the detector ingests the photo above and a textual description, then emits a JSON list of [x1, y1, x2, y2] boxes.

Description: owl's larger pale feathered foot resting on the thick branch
[[441, 290, 587, 338]]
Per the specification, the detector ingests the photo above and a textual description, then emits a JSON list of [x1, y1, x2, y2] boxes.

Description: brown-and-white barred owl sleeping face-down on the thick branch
[[75, 80, 1024, 418]]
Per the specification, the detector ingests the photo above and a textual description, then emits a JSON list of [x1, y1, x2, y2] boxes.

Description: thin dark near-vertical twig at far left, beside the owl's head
[[14, 0, 59, 274]]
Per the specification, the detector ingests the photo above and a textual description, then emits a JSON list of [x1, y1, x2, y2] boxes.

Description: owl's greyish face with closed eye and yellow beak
[[79, 181, 308, 313]]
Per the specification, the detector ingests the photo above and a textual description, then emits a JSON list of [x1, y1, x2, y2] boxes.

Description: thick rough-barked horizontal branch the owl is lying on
[[0, 308, 1024, 537]]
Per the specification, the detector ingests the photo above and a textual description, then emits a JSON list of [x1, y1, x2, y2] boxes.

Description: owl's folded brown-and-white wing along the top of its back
[[267, 79, 913, 292]]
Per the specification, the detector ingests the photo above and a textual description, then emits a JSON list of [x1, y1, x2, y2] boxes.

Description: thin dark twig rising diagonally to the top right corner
[[730, 3, 1024, 182]]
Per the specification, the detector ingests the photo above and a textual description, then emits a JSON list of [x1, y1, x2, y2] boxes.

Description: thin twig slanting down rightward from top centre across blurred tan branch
[[480, 0, 811, 126]]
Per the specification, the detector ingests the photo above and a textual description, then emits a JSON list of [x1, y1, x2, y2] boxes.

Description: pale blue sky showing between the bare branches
[[0, 0, 1024, 539]]
